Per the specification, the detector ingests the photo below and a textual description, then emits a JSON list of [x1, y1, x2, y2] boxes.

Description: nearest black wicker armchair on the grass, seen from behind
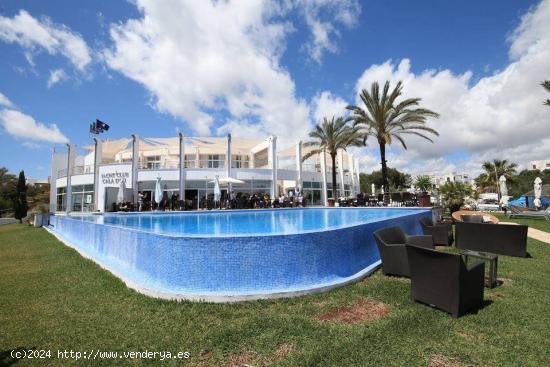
[[407, 245, 485, 318]]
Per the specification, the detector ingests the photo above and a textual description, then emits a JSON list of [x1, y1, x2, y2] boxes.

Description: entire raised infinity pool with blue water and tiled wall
[[48, 208, 431, 302]]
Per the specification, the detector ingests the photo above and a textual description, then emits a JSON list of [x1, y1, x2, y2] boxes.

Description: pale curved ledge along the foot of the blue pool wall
[[43, 227, 382, 303]]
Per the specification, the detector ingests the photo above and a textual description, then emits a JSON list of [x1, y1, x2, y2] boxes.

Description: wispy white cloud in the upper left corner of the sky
[[0, 10, 92, 71]]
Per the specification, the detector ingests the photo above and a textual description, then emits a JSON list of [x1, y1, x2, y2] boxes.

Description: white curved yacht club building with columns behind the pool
[[50, 134, 359, 212]]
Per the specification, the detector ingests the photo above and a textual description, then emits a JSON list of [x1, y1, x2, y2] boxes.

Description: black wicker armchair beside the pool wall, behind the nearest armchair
[[374, 227, 434, 277]]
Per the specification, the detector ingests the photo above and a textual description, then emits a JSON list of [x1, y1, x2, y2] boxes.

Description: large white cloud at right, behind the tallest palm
[[355, 0, 550, 177]]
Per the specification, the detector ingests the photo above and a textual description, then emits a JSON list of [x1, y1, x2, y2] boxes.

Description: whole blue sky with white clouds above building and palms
[[0, 0, 550, 177]]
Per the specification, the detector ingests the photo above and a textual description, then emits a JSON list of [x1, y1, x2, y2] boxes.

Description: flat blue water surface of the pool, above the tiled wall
[[71, 208, 425, 237]]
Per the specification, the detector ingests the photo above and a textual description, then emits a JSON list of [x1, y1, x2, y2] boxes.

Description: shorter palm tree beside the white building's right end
[[302, 117, 365, 203]]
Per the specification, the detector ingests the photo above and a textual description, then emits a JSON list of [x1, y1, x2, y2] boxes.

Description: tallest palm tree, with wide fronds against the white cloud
[[347, 81, 439, 204]]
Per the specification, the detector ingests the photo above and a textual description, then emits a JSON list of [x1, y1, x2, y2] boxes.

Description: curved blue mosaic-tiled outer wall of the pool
[[49, 209, 431, 300]]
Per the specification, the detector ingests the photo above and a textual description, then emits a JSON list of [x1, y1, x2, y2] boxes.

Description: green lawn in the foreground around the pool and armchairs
[[0, 225, 550, 366]]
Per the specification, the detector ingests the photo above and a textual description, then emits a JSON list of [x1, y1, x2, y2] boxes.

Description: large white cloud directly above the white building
[[104, 0, 355, 147]]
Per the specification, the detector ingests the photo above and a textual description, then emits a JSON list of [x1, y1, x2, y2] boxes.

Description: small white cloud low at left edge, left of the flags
[[0, 109, 69, 143]]
